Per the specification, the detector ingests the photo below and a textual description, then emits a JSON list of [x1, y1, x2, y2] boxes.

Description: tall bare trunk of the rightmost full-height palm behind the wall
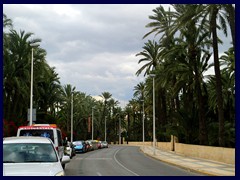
[[210, 8, 225, 147]]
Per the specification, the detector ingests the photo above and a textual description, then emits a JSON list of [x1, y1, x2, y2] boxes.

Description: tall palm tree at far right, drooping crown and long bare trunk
[[196, 4, 235, 146]]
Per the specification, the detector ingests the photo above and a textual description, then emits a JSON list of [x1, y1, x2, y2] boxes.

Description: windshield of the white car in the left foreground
[[3, 143, 58, 163]]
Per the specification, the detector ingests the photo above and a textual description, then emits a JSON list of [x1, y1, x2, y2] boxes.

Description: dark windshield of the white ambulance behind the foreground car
[[19, 129, 54, 142]]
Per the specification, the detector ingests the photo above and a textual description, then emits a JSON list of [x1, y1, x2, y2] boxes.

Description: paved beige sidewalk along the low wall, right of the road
[[140, 146, 235, 176]]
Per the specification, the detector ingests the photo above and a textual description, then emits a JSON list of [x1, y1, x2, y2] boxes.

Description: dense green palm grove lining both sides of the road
[[3, 4, 235, 147]]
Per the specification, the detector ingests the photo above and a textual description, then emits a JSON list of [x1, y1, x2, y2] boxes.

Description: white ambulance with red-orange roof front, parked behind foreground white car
[[17, 124, 65, 168]]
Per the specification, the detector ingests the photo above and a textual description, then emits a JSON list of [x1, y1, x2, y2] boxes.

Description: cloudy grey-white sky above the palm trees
[[3, 4, 230, 107]]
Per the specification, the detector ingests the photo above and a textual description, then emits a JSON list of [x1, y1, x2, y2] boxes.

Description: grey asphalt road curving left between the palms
[[65, 145, 204, 176]]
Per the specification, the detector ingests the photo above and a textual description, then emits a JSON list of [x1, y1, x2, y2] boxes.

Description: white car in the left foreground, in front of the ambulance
[[3, 136, 70, 176]]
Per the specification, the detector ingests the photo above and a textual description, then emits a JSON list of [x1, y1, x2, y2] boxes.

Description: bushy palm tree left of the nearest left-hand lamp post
[[3, 30, 41, 123]]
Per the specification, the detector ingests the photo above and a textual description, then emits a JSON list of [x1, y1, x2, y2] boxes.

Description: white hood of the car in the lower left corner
[[3, 162, 63, 176]]
